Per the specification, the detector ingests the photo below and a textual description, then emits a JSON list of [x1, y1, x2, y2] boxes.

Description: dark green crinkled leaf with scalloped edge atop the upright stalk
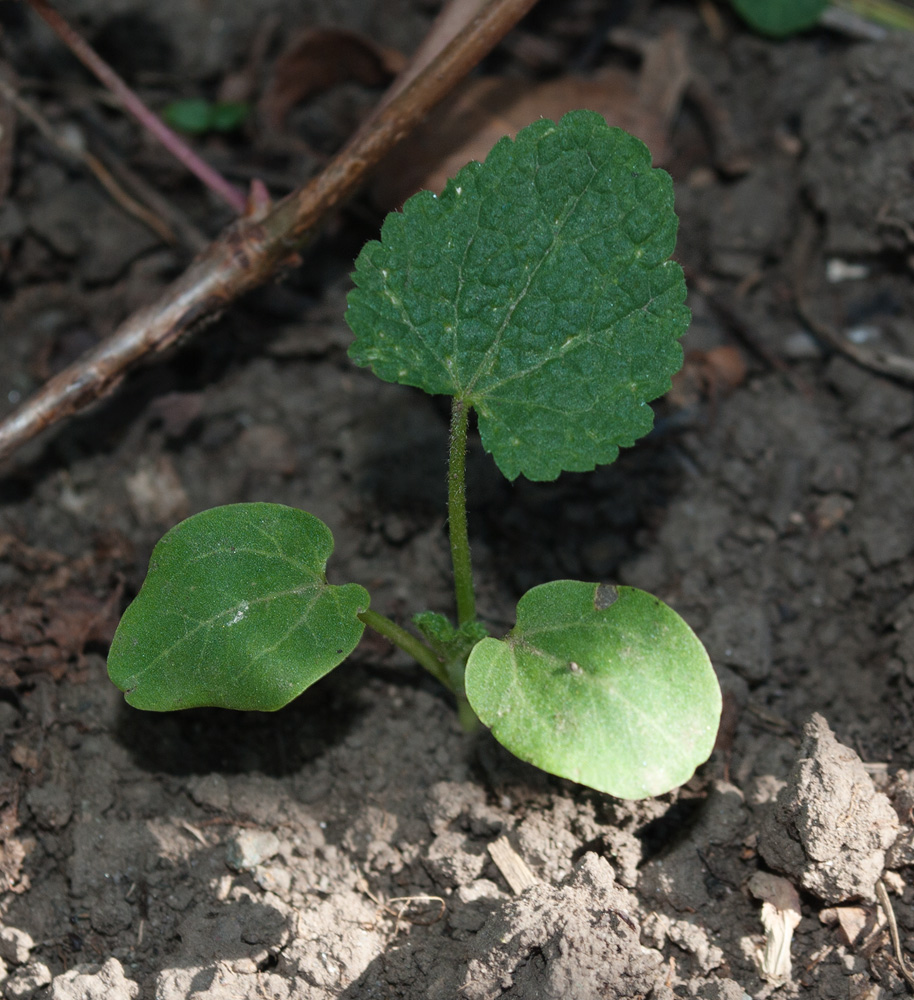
[[346, 111, 689, 480]]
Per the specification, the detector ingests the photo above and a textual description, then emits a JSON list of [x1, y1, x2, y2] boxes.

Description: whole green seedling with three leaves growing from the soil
[[108, 111, 721, 798]]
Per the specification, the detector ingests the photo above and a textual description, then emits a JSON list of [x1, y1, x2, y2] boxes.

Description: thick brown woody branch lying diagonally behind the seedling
[[0, 0, 536, 460]]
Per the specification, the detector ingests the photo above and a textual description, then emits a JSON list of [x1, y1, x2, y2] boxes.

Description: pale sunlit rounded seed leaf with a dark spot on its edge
[[466, 580, 721, 799]]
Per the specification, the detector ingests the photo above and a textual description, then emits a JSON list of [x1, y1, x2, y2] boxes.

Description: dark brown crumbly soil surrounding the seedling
[[0, 0, 914, 1000]]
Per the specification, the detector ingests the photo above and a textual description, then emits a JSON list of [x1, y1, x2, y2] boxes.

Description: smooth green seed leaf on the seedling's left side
[[108, 503, 369, 712]]
